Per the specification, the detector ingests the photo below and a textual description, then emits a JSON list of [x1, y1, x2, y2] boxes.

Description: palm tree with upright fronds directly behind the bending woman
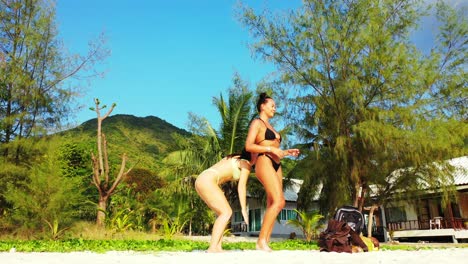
[[163, 74, 252, 232]]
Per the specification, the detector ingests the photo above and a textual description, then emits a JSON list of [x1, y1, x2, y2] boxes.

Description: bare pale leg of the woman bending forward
[[195, 172, 232, 252]]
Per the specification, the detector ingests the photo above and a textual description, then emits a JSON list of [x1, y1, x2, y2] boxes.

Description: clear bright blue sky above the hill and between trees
[[56, 0, 457, 131]]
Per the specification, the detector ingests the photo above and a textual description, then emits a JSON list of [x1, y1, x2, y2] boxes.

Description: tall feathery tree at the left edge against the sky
[[0, 0, 109, 164]]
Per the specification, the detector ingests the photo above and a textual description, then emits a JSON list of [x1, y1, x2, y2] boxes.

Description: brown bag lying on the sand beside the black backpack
[[318, 219, 352, 253]]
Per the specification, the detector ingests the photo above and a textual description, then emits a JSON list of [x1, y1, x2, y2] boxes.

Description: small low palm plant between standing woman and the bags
[[287, 210, 323, 242]]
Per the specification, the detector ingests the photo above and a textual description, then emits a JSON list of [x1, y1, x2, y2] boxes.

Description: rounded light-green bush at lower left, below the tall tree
[[5, 148, 84, 238]]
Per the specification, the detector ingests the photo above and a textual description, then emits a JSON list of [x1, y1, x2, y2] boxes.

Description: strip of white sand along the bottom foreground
[[0, 248, 468, 264]]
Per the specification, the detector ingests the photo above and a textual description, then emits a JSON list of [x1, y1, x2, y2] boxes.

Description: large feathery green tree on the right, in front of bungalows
[[239, 0, 468, 218]]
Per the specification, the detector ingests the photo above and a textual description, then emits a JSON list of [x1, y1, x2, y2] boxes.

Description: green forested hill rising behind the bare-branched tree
[[60, 115, 190, 170]]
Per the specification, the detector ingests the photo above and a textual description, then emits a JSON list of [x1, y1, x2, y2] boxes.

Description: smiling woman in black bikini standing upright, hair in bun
[[245, 93, 299, 251]]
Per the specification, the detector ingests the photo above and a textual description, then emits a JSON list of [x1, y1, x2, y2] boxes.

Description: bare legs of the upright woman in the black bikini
[[256, 156, 285, 251]]
